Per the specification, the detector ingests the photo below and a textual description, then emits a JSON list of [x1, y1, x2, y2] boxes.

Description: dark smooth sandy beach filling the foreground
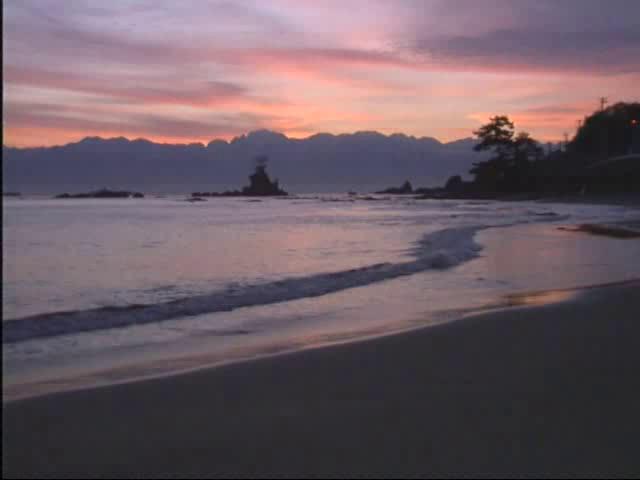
[[3, 280, 640, 478]]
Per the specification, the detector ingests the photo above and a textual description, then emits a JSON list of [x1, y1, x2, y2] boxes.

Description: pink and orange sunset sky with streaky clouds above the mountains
[[3, 0, 640, 146]]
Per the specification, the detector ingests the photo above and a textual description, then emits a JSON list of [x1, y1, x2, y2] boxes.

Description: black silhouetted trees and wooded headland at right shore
[[416, 102, 640, 198]]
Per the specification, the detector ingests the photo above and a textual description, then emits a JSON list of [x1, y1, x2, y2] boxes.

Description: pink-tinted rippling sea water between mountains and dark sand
[[2, 195, 640, 398]]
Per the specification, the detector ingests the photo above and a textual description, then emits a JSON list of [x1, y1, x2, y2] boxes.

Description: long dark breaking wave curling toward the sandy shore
[[2, 226, 488, 343]]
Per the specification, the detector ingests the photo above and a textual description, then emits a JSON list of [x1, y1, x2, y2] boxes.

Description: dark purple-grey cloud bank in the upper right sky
[[398, 0, 640, 74]]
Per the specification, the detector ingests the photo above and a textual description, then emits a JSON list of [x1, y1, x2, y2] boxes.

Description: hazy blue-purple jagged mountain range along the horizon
[[2, 130, 478, 193]]
